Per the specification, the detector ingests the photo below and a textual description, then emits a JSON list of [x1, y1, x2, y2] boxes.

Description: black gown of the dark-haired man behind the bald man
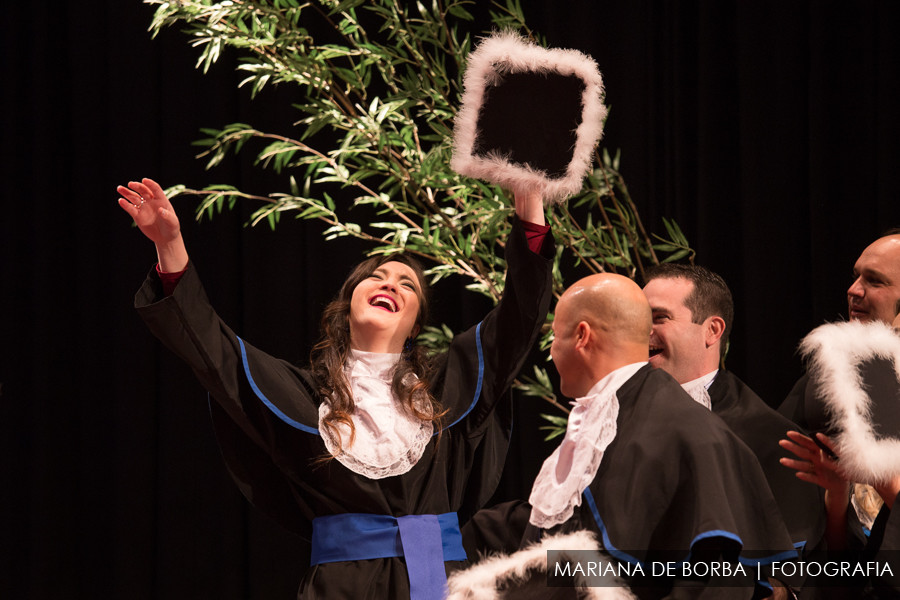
[[709, 370, 825, 550]]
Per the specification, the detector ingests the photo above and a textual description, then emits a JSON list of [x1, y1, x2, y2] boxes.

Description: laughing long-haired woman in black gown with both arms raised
[[118, 179, 554, 599]]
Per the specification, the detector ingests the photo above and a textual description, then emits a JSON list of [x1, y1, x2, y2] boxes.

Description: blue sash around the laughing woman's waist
[[310, 512, 466, 600]]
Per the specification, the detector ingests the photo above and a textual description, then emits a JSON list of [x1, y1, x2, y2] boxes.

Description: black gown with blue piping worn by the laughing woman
[[135, 219, 553, 600]]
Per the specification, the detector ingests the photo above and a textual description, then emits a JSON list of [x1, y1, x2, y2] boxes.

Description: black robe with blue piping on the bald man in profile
[[463, 365, 796, 599]]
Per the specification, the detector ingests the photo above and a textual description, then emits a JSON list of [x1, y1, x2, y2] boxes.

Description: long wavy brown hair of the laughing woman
[[309, 254, 444, 460]]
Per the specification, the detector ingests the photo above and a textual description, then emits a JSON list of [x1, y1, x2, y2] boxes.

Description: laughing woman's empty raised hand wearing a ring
[[116, 178, 188, 273]]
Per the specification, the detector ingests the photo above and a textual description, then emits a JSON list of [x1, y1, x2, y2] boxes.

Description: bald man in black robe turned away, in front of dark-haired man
[[458, 274, 796, 598]]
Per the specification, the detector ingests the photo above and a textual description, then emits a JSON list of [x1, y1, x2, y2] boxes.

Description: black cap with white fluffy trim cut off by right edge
[[800, 321, 900, 484]]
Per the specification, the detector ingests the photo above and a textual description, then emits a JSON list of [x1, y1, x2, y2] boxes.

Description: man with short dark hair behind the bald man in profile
[[644, 264, 825, 550]]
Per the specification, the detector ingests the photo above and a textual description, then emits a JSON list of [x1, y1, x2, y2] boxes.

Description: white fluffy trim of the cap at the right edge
[[800, 321, 900, 484]]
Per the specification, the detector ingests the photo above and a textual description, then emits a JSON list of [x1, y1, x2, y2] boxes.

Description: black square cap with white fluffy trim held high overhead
[[451, 32, 606, 202]]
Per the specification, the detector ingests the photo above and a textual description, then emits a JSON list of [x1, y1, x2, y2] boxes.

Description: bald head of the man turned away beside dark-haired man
[[550, 273, 652, 398]]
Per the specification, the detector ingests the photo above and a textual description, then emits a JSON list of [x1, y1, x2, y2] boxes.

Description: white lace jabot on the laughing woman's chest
[[319, 350, 434, 479]]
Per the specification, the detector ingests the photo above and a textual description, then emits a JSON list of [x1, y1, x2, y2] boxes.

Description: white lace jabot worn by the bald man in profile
[[528, 362, 647, 529]]
